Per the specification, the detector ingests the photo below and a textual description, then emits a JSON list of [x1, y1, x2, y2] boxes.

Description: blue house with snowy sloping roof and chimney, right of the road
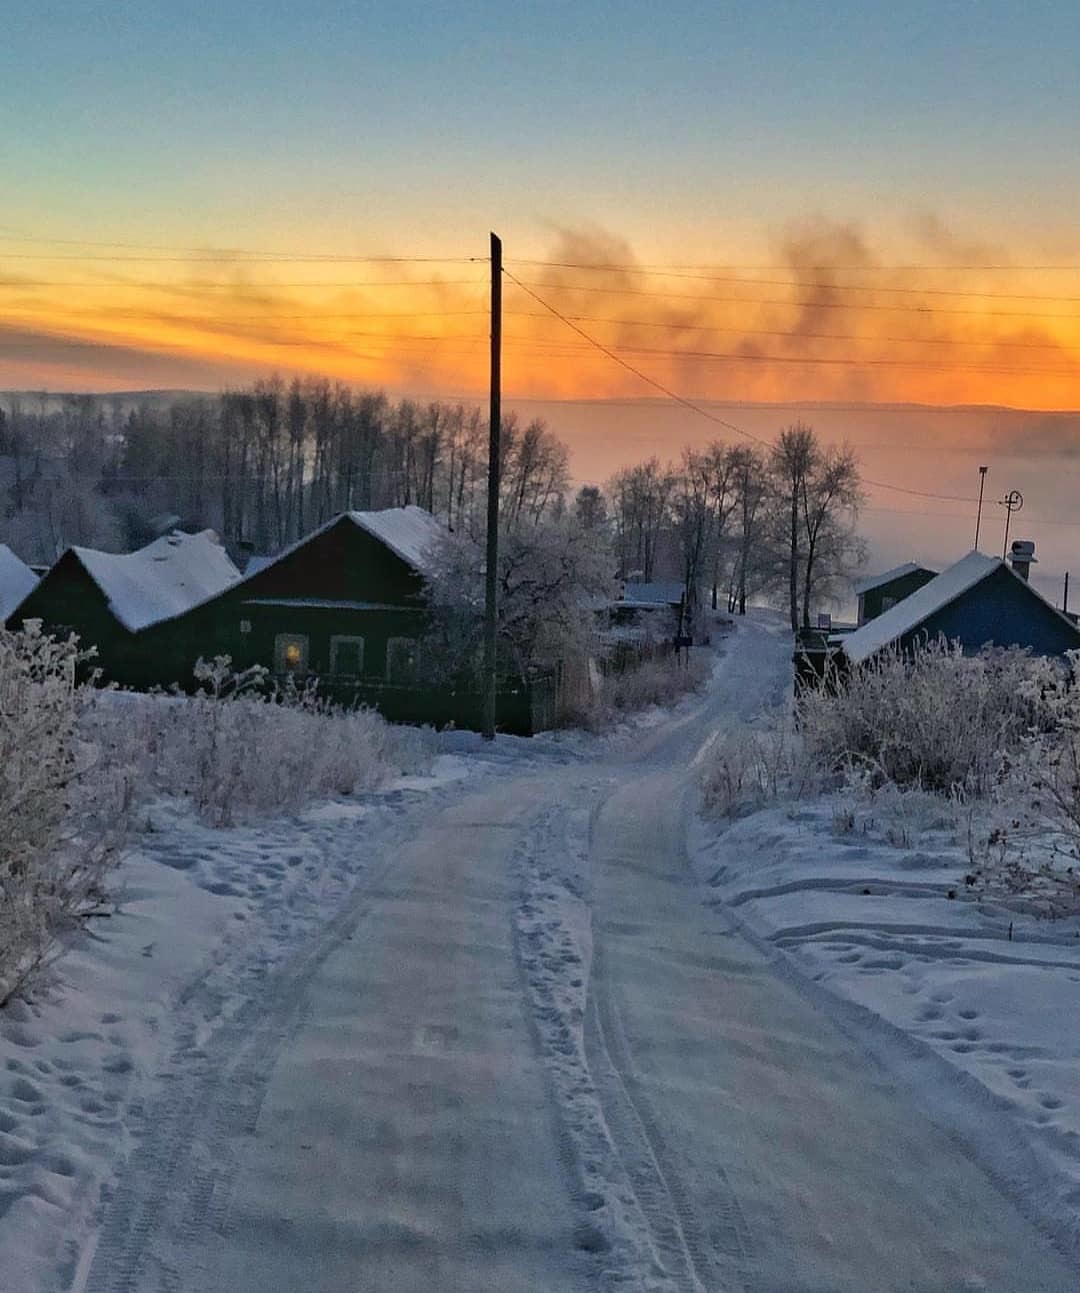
[[837, 552, 1080, 665]]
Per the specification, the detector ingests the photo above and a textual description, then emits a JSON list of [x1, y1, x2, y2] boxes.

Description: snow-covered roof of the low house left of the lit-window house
[[71, 530, 241, 632]]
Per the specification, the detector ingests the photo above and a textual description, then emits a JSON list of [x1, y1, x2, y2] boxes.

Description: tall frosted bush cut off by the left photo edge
[[0, 622, 131, 1003]]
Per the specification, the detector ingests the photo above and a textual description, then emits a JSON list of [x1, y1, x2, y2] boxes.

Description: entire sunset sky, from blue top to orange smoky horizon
[[0, 0, 1080, 584]]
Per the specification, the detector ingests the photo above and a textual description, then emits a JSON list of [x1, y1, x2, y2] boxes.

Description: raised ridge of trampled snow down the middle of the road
[[515, 786, 748, 1293]]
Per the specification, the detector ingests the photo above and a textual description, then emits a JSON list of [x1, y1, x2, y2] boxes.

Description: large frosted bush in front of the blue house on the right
[[795, 640, 1062, 796]]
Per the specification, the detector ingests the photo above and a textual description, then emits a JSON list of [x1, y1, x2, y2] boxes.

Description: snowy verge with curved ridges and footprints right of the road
[[693, 744, 1080, 1253]]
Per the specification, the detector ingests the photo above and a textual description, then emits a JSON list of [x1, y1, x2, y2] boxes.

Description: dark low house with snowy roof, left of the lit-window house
[[6, 530, 241, 687]]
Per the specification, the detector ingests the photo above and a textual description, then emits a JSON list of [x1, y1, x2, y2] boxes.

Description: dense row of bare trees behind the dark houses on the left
[[0, 379, 569, 564]]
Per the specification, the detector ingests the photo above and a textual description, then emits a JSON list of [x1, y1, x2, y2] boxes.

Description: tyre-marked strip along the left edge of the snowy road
[[79, 815, 432, 1293]]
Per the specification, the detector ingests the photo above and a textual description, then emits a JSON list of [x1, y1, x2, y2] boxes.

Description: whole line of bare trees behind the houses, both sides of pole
[[0, 379, 864, 630]]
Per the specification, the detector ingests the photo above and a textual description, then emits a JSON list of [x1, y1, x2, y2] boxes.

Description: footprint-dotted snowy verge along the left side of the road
[[0, 733, 581, 1293]]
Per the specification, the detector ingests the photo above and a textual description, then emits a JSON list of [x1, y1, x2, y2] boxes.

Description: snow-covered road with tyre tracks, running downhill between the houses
[[61, 625, 1077, 1293]]
